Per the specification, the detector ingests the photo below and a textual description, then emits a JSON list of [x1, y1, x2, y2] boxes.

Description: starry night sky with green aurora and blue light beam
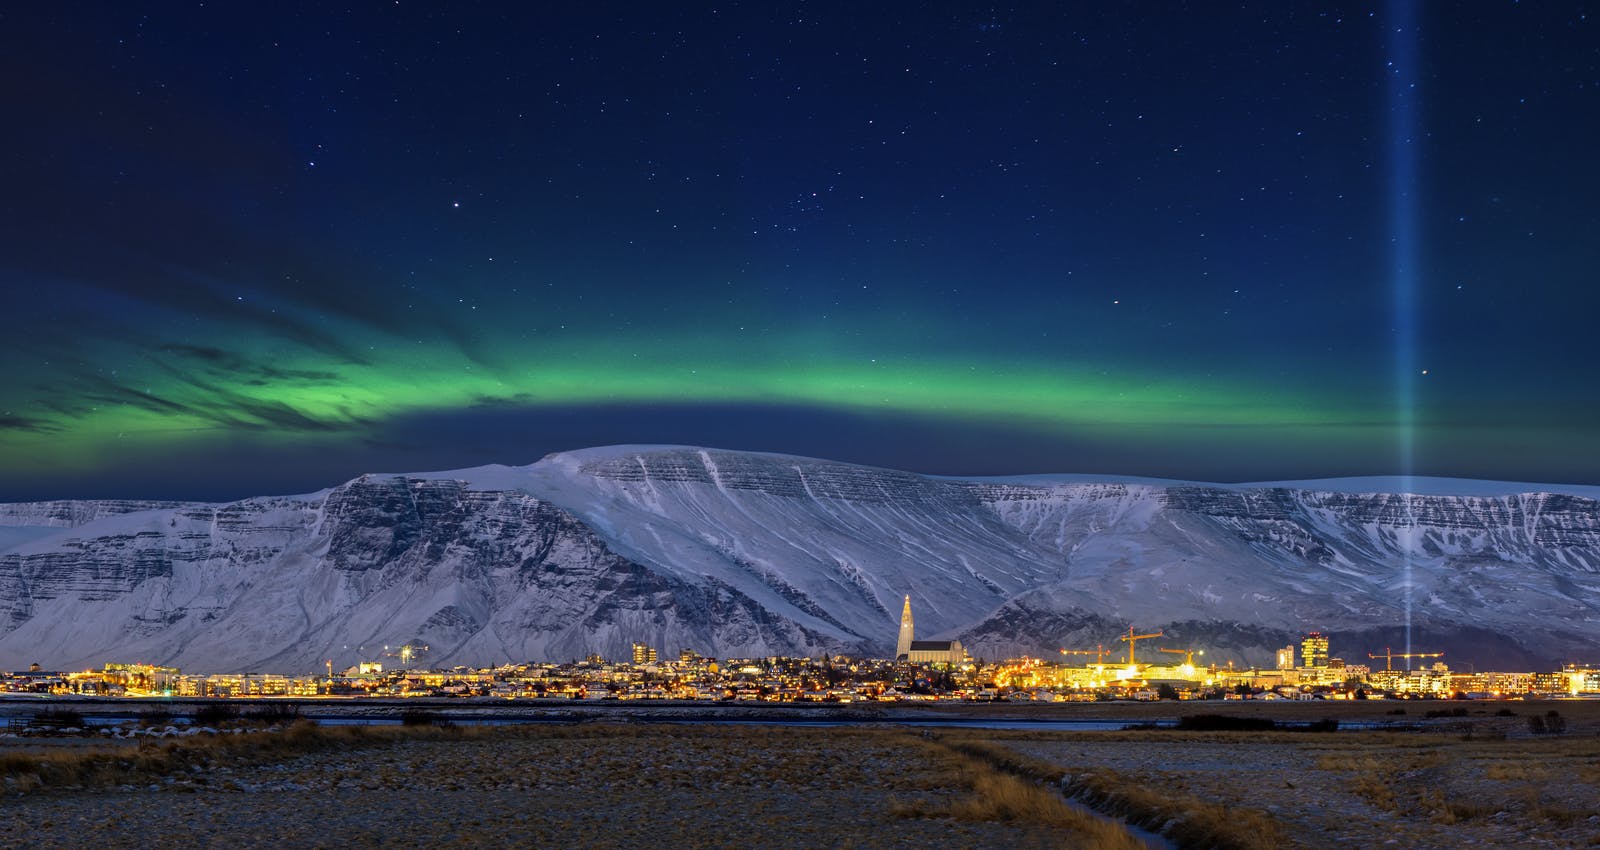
[[0, 0, 1600, 499]]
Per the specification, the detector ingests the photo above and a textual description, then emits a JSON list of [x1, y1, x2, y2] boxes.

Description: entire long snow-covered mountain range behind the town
[[0, 447, 1600, 672]]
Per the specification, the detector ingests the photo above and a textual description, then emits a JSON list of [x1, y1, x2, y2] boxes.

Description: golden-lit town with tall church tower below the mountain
[[9, 599, 1600, 703]]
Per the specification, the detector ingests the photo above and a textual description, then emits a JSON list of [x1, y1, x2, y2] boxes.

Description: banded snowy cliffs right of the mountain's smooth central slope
[[968, 482, 1600, 668]]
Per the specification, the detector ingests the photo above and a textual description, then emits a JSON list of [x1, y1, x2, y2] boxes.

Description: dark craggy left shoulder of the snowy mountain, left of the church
[[0, 477, 848, 671]]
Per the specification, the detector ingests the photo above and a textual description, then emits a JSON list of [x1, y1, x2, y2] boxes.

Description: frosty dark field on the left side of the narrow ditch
[[0, 725, 1138, 850]]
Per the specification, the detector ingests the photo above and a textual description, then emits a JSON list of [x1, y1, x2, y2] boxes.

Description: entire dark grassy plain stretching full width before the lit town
[[0, 706, 1600, 848]]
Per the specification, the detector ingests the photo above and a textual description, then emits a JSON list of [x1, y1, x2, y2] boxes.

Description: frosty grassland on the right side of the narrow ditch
[[992, 732, 1600, 848]]
